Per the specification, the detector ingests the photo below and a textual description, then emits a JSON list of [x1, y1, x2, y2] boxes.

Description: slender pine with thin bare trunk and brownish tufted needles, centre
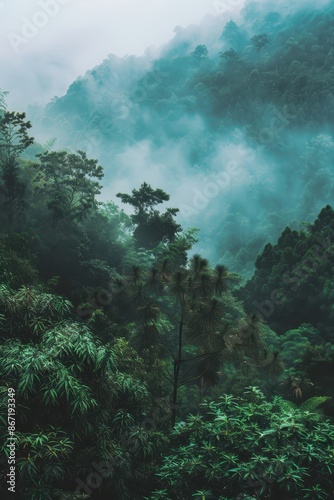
[[112, 255, 259, 426]]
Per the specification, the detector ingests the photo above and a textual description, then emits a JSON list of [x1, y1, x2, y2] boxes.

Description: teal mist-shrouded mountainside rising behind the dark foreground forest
[[28, 3, 334, 277]]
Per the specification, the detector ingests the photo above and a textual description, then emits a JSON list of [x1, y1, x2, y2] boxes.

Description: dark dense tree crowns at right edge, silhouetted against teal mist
[[240, 206, 334, 338]]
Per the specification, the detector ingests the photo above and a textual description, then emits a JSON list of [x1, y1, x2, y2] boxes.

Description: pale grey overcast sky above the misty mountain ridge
[[0, 0, 243, 107]]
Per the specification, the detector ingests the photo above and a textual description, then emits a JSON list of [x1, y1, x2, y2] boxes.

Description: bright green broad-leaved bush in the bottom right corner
[[152, 387, 334, 500]]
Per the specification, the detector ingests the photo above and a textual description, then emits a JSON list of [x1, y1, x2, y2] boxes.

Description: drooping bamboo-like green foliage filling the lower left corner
[[0, 286, 161, 499]]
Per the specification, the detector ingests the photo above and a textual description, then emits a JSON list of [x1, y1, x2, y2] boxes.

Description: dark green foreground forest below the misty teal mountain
[[0, 103, 334, 500]]
